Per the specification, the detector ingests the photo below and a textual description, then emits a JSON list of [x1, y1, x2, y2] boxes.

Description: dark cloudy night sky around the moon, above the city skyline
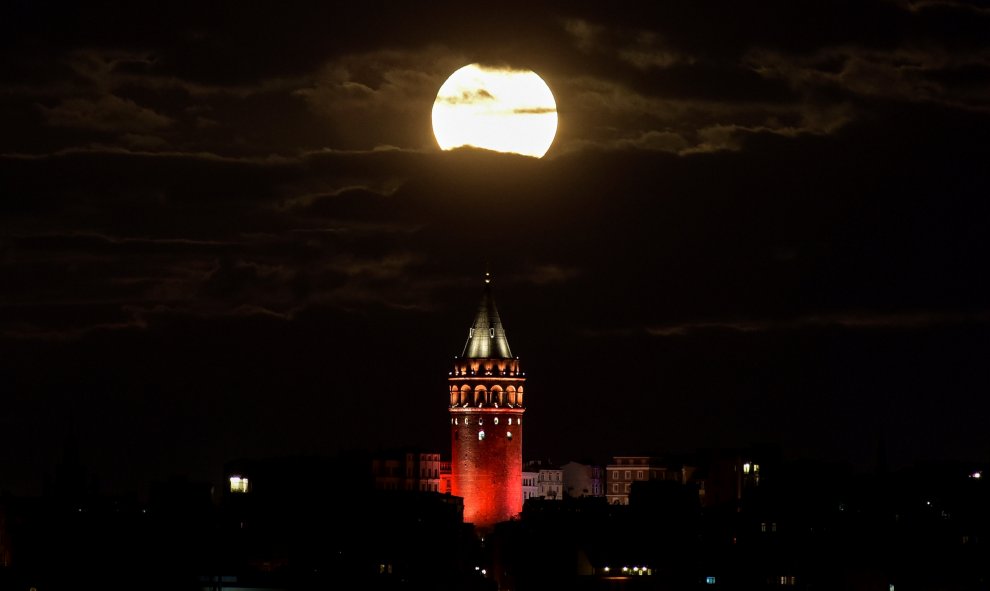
[[0, 0, 990, 494]]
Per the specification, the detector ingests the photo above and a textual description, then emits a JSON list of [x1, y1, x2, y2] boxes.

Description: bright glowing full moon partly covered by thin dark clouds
[[433, 64, 557, 158]]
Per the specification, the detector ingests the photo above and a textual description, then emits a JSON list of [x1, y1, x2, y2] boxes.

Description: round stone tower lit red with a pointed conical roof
[[448, 273, 526, 531]]
